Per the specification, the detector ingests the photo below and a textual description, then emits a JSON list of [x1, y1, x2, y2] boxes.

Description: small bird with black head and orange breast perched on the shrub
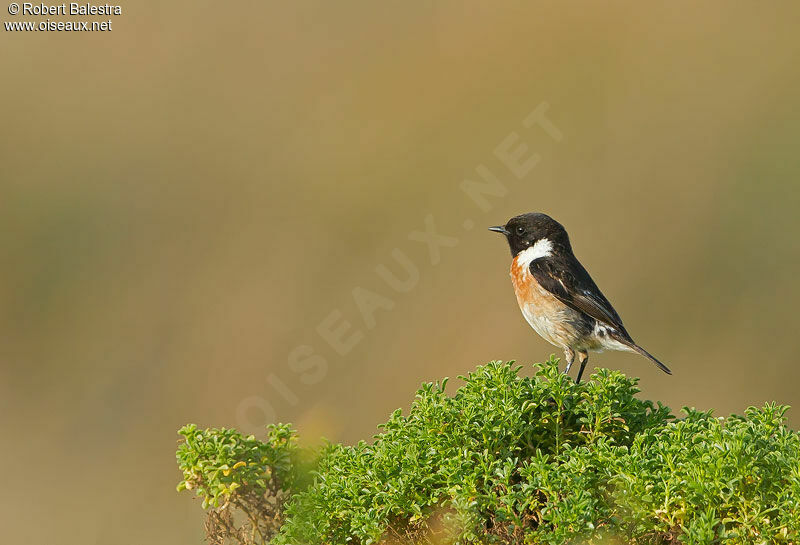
[[489, 213, 672, 382]]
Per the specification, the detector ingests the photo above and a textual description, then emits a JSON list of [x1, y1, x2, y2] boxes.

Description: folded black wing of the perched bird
[[530, 256, 633, 342]]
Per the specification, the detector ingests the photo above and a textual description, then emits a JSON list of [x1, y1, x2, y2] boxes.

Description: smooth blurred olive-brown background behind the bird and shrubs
[[0, 1, 800, 544]]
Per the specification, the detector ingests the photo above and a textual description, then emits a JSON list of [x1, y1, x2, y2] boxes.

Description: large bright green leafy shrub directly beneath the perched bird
[[179, 358, 800, 545]]
